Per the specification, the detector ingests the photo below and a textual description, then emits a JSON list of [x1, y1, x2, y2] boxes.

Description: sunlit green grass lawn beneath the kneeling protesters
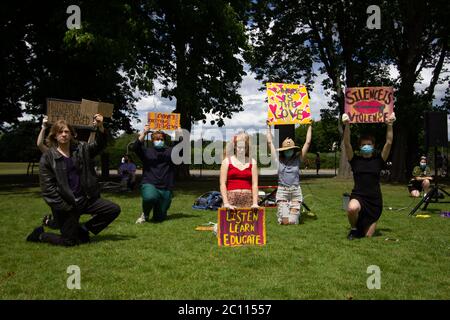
[[0, 170, 450, 299]]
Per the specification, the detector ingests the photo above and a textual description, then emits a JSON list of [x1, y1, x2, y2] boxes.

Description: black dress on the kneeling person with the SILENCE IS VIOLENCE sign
[[350, 155, 385, 232]]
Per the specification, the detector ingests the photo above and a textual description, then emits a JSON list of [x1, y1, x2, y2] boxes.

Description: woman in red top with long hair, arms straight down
[[220, 133, 258, 209]]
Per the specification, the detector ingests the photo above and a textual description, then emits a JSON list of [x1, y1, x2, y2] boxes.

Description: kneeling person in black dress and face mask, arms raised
[[342, 113, 395, 240]]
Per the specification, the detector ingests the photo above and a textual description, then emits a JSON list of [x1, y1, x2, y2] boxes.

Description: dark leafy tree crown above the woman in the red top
[[136, 0, 248, 131]]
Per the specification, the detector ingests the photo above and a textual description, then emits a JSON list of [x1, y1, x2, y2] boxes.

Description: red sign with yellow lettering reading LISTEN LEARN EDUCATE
[[217, 208, 266, 247]]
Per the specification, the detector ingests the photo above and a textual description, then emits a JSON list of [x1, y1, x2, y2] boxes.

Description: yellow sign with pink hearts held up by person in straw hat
[[266, 83, 311, 125]]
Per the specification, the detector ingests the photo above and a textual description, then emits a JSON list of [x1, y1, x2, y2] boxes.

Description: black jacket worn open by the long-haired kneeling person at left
[[39, 129, 106, 211]]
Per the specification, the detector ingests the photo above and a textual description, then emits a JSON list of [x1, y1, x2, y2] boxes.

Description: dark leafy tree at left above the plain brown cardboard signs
[[0, 0, 156, 132]]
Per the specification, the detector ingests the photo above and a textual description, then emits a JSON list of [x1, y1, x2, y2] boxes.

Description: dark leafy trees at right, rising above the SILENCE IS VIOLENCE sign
[[251, 0, 449, 181]]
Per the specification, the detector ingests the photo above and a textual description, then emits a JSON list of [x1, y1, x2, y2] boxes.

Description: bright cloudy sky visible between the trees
[[133, 65, 450, 140]]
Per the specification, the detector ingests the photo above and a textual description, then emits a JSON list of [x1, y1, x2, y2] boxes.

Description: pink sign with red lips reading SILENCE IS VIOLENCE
[[345, 87, 394, 123]]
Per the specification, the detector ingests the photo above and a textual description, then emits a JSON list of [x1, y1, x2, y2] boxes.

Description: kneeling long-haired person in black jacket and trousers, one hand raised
[[27, 114, 120, 246]]
